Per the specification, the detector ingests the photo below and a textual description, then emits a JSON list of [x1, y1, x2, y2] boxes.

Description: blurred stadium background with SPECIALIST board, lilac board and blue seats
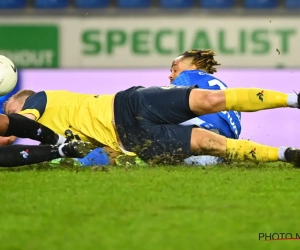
[[0, 0, 300, 147]]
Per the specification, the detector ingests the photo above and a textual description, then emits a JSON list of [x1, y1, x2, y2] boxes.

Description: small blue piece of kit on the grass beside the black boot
[[77, 148, 110, 167]]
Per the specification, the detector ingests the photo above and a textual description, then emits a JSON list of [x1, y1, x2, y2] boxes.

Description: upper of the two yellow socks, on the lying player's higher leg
[[224, 88, 290, 111]]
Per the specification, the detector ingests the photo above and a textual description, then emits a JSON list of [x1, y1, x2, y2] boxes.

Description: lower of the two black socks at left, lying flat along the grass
[[0, 145, 61, 167]]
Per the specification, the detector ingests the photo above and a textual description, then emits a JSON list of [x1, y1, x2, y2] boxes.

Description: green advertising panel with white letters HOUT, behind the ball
[[0, 24, 60, 68]]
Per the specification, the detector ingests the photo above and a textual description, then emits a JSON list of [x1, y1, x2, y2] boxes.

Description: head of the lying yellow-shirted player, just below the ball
[[3, 89, 35, 114]]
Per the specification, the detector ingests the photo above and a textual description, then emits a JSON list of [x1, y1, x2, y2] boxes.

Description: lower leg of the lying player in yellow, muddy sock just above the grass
[[191, 128, 300, 167]]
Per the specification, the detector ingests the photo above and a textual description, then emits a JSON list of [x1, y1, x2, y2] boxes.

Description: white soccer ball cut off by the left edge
[[0, 55, 18, 96]]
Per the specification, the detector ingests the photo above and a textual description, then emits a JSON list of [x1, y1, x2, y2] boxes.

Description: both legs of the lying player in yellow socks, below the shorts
[[189, 88, 300, 167]]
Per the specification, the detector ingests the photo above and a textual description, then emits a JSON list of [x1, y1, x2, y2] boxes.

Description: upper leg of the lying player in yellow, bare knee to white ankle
[[189, 88, 300, 115]]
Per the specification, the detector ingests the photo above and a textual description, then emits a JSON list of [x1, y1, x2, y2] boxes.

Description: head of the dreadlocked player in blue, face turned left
[[169, 50, 221, 83]]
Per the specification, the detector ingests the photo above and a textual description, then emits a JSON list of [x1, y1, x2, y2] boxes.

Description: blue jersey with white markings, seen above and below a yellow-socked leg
[[172, 70, 241, 139]]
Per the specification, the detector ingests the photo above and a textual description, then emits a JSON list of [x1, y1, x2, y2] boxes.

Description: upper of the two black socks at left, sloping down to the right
[[4, 114, 63, 145]]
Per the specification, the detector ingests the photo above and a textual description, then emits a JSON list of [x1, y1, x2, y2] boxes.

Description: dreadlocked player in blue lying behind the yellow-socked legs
[[169, 50, 241, 165]]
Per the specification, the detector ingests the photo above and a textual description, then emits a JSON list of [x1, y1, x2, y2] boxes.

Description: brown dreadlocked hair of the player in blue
[[179, 49, 221, 74]]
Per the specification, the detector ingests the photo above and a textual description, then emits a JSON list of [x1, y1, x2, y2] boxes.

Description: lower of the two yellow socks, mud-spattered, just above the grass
[[226, 139, 280, 162]]
